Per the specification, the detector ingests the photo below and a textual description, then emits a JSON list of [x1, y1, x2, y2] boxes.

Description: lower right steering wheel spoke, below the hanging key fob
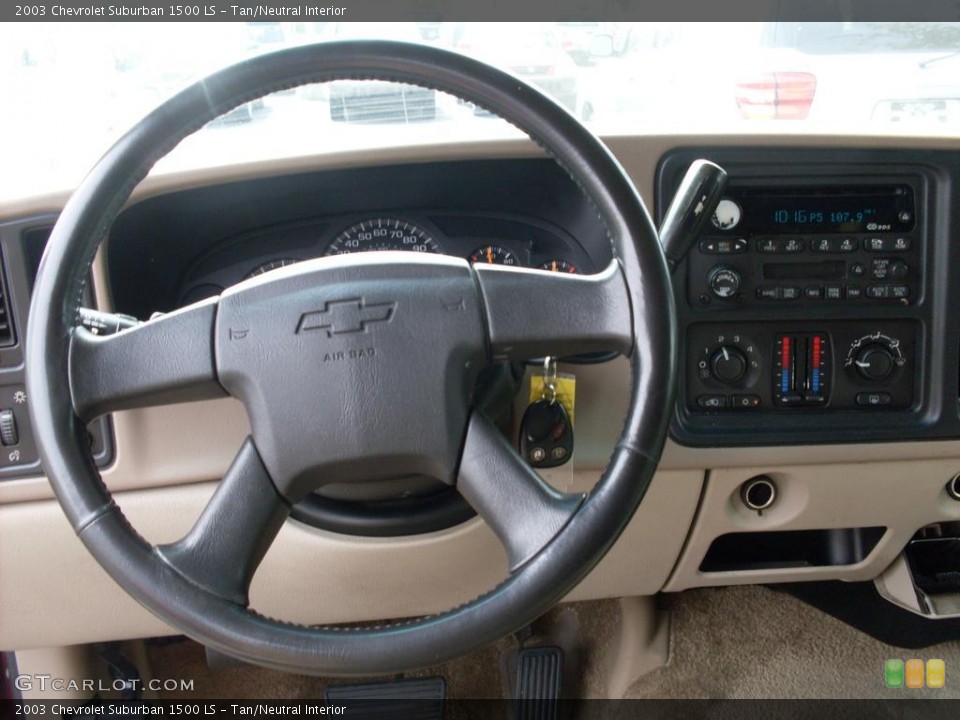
[[457, 413, 584, 572]]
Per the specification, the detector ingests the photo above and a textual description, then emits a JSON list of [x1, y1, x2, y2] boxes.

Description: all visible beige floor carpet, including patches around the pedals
[[150, 587, 960, 700]]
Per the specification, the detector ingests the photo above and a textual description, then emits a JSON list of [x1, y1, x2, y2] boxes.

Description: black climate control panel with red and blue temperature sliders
[[685, 320, 918, 413]]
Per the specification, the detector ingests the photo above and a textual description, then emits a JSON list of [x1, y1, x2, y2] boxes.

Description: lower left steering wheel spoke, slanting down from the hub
[[157, 438, 290, 607]]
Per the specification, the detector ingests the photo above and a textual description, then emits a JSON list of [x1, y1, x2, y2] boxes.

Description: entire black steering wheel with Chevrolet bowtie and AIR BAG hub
[[26, 41, 676, 675]]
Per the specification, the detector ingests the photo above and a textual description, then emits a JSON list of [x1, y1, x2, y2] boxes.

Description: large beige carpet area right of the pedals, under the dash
[[626, 587, 960, 699]]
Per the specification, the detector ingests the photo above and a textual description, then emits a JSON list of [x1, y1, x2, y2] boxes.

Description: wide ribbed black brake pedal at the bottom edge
[[323, 677, 447, 720]]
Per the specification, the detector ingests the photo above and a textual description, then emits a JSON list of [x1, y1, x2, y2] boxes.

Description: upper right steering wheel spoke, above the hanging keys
[[474, 260, 633, 360]]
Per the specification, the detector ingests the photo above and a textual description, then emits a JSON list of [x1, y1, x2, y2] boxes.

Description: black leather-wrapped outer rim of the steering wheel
[[26, 41, 676, 675]]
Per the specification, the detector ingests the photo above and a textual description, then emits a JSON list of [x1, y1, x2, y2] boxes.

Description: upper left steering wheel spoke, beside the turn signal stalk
[[70, 298, 226, 421]]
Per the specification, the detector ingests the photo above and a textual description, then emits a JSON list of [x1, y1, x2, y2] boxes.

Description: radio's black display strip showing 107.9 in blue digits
[[714, 185, 915, 234]]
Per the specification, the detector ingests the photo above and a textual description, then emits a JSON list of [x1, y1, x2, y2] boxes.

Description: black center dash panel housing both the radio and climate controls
[[656, 147, 960, 447]]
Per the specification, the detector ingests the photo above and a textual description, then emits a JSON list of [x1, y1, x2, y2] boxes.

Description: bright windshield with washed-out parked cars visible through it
[[0, 22, 960, 200]]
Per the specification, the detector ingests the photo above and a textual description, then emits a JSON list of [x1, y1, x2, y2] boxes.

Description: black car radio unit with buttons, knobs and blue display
[[687, 182, 921, 309]]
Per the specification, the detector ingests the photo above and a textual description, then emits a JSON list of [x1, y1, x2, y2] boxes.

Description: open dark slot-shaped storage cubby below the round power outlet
[[700, 527, 886, 572]]
